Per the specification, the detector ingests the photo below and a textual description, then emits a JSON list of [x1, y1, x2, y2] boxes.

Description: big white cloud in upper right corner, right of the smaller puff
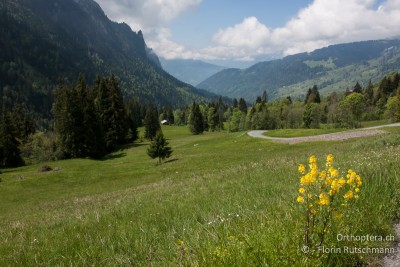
[[267, 0, 400, 54]]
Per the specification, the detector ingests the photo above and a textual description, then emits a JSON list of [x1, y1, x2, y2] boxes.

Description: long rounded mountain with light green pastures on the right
[[197, 40, 400, 101]]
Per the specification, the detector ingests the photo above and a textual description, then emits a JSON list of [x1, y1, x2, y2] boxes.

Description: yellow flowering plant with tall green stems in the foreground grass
[[296, 154, 362, 255]]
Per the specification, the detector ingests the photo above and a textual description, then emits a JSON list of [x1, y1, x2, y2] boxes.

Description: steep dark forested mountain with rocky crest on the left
[[0, 0, 214, 117]]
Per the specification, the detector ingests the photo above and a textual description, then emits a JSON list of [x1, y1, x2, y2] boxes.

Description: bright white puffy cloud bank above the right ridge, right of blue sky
[[203, 0, 400, 60]]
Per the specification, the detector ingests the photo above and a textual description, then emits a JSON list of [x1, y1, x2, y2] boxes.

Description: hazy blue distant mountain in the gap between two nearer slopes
[[161, 58, 225, 86]]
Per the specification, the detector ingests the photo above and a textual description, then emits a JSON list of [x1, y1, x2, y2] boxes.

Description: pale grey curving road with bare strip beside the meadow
[[247, 123, 400, 144]]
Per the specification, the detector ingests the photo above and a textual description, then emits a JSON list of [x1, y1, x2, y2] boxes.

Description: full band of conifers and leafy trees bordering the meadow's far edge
[[0, 70, 400, 167]]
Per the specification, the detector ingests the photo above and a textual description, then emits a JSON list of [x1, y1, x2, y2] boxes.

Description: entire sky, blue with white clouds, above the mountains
[[96, 0, 400, 67]]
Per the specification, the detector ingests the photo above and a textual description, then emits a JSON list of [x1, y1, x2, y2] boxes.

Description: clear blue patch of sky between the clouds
[[170, 0, 312, 46]]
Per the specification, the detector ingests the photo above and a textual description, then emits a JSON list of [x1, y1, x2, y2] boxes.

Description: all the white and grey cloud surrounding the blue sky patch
[[97, 0, 400, 61]]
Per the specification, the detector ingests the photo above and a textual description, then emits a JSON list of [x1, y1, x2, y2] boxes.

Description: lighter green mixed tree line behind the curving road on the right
[[224, 73, 400, 132]]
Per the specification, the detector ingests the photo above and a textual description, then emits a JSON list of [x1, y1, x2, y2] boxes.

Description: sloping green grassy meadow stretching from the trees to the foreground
[[0, 126, 400, 266]]
